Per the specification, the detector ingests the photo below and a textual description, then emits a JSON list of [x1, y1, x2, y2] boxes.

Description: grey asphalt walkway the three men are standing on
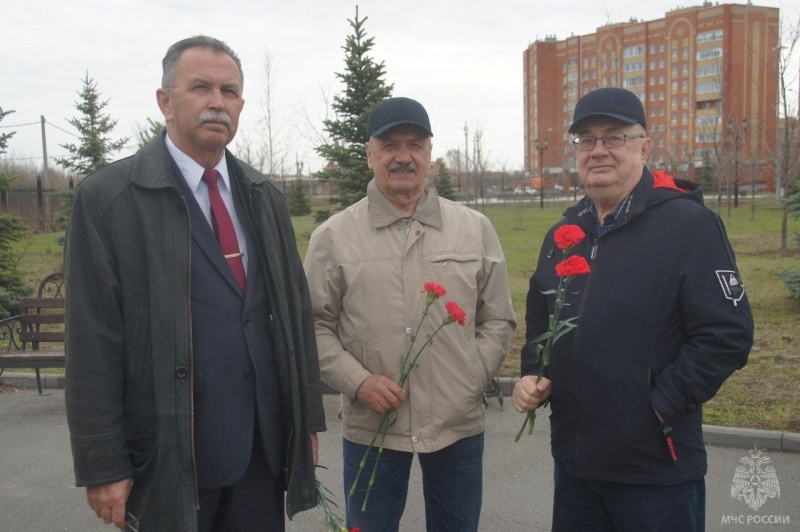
[[0, 377, 800, 532]]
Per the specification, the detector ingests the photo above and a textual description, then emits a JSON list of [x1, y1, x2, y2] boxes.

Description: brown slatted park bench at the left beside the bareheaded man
[[0, 273, 64, 395]]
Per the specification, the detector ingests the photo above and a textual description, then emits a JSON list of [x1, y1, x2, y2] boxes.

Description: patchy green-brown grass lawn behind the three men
[[12, 195, 800, 432]]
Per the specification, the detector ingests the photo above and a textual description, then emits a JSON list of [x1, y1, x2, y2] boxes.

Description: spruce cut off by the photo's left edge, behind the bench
[[0, 107, 30, 318]]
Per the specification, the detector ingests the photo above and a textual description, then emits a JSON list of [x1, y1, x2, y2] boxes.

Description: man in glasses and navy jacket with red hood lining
[[512, 88, 753, 531]]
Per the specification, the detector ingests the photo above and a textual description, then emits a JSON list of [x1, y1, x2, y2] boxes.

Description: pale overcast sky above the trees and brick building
[[0, 0, 799, 173]]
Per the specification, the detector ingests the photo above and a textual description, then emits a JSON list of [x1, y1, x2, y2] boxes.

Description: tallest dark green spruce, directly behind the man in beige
[[315, 6, 394, 207]]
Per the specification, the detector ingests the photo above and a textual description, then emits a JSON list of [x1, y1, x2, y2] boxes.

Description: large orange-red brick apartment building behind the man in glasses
[[523, 2, 779, 190]]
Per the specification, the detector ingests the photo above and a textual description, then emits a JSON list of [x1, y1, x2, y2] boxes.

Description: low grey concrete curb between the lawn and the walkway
[[0, 372, 800, 453]]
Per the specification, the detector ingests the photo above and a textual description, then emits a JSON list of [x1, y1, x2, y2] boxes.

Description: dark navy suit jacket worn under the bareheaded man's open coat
[[176, 164, 285, 488]]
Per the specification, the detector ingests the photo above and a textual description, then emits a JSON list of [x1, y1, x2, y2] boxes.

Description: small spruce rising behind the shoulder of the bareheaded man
[[56, 72, 128, 176]]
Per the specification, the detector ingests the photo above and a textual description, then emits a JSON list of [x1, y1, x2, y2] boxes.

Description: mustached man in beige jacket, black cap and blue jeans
[[305, 98, 516, 532]]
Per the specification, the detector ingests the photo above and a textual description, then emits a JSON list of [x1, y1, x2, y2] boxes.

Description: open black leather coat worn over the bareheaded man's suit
[[65, 134, 325, 531]]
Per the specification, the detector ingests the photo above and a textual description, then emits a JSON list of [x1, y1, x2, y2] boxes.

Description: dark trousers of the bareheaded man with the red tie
[[197, 423, 286, 532]]
